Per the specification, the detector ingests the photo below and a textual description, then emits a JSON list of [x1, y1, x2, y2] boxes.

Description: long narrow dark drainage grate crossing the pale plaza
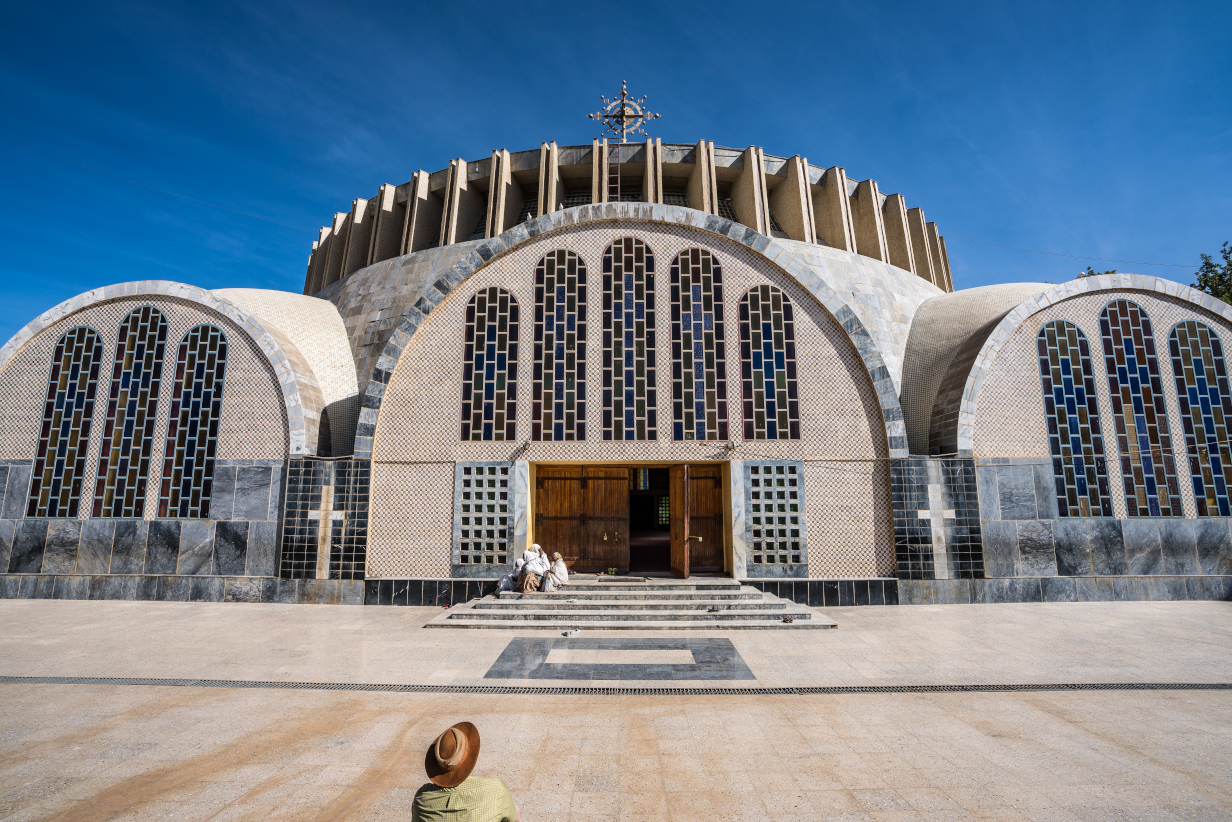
[[0, 677, 1232, 696]]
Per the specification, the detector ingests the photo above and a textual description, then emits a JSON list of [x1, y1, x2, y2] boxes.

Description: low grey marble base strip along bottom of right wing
[[898, 576, 1232, 605]]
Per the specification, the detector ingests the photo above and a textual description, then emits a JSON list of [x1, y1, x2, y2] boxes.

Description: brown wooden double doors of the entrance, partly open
[[535, 465, 723, 578]]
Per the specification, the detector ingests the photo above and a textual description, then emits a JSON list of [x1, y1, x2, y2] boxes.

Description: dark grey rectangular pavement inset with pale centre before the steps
[[484, 637, 756, 680]]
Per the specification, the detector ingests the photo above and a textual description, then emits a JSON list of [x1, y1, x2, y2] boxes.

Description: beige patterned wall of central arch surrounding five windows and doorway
[[368, 222, 891, 578]]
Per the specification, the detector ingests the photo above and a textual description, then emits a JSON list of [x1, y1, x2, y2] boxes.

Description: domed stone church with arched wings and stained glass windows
[[0, 99, 1232, 606]]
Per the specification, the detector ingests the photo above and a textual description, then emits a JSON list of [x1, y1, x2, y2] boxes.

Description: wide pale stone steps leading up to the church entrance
[[424, 574, 838, 631]]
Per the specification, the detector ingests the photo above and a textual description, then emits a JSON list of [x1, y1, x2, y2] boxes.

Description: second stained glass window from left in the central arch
[[531, 249, 586, 441]]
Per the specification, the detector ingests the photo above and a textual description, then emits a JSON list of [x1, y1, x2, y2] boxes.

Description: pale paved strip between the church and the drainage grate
[[0, 600, 1232, 686]]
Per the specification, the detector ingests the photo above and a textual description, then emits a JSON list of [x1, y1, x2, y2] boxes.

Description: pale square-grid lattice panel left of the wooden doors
[[453, 462, 515, 577]]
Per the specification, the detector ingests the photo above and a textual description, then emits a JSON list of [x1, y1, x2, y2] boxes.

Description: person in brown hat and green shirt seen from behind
[[410, 722, 521, 822]]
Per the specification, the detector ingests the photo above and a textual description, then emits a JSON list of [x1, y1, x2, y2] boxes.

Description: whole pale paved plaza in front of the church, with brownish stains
[[0, 600, 1232, 822]]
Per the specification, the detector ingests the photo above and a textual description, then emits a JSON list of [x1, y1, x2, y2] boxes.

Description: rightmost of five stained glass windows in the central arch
[[740, 286, 800, 440]]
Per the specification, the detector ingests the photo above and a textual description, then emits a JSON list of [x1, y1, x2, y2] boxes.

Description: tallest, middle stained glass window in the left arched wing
[[94, 306, 166, 518]]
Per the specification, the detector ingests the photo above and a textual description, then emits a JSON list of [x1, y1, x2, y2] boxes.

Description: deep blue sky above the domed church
[[0, 0, 1232, 340]]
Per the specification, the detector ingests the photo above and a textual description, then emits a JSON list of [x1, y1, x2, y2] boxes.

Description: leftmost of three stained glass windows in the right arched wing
[[1035, 319, 1112, 516]]
